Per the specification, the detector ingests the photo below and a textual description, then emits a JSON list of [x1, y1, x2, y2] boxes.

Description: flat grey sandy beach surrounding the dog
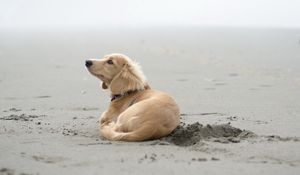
[[0, 28, 300, 175]]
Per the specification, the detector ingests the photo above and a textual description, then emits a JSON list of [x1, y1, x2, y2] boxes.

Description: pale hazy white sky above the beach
[[0, 0, 300, 28]]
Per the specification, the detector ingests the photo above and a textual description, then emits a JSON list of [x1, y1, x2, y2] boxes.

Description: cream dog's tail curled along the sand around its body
[[100, 124, 155, 141]]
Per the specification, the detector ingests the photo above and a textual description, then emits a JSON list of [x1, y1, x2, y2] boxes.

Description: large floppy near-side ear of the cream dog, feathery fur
[[110, 63, 146, 94]]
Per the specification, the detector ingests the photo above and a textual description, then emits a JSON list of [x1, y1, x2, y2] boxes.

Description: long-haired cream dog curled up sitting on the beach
[[85, 54, 180, 141]]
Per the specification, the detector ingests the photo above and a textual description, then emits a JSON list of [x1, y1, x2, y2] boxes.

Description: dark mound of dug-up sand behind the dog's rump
[[163, 122, 256, 146]]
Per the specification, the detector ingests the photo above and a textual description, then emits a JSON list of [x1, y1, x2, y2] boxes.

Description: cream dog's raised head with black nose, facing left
[[85, 54, 147, 94]]
